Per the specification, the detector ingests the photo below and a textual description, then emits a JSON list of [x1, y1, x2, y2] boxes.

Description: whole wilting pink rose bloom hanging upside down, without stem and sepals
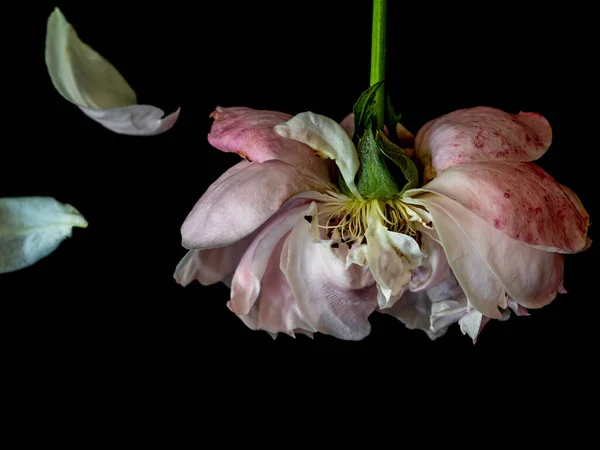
[[175, 104, 588, 340]]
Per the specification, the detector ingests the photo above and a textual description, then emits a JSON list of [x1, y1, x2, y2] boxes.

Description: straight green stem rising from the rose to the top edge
[[371, 0, 387, 130]]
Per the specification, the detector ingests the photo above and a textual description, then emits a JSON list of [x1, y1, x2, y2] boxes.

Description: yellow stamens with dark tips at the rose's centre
[[318, 191, 421, 245]]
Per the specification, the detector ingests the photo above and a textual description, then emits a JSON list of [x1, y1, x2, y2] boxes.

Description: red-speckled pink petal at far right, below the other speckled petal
[[407, 161, 589, 253]]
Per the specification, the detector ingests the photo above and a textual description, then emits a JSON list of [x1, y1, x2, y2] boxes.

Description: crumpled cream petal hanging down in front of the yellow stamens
[[365, 207, 425, 309]]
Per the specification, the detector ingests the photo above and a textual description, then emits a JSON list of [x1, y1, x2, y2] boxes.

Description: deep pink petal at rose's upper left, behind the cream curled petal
[[208, 107, 331, 180]]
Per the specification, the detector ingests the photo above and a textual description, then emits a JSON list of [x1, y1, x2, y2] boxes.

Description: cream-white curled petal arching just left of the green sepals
[[275, 112, 362, 200]]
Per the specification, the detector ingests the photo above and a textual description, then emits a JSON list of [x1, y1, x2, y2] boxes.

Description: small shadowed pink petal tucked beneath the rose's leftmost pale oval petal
[[173, 233, 255, 286]]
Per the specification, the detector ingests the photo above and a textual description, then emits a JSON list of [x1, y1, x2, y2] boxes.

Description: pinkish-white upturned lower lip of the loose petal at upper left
[[79, 105, 180, 136]]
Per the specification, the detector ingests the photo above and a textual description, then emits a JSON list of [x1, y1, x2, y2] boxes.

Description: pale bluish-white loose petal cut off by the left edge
[[0, 197, 88, 273]]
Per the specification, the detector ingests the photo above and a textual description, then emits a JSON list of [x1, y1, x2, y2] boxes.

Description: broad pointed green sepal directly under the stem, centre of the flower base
[[356, 125, 398, 199]]
